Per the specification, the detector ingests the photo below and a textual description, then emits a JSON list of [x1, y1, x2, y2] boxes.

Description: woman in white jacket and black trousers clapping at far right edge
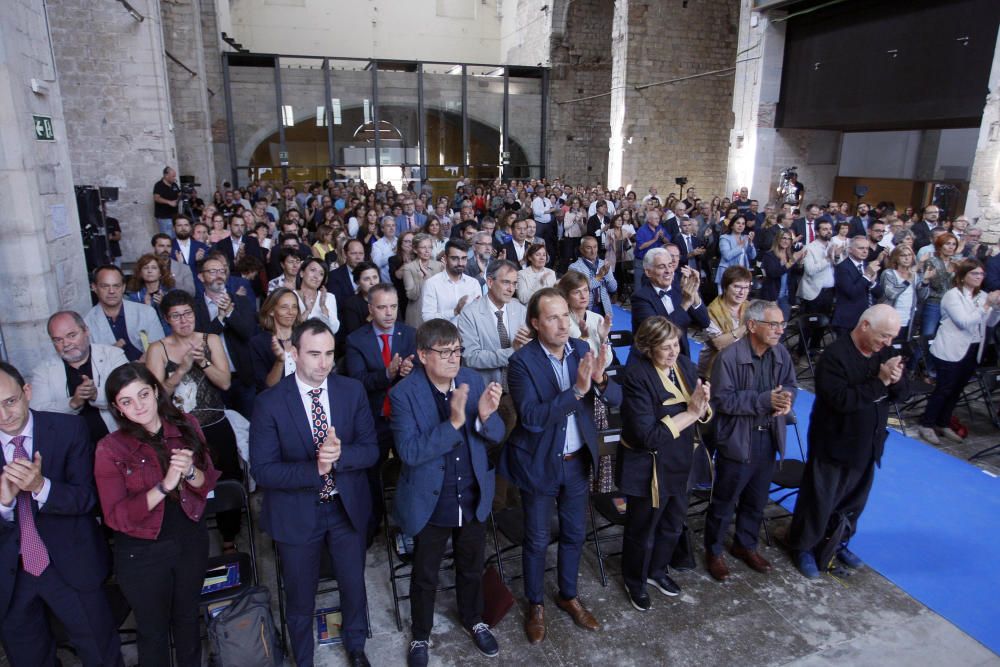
[[918, 259, 1000, 445]]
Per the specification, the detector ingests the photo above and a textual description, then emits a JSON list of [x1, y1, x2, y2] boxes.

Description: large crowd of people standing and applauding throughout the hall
[[0, 172, 1000, 666]]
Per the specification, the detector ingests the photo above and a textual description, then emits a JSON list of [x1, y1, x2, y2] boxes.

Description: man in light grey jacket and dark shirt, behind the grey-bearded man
[[83, 264, 165, 361]]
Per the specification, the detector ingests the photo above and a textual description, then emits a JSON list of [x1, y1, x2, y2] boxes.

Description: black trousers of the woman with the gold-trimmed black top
[[622, 493, 688, 593]]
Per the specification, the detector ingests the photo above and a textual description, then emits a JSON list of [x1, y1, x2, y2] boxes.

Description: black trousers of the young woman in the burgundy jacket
[[115, 523, 208, 667]]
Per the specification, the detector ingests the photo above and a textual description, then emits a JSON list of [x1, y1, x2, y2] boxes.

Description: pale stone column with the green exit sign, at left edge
[[0, 0, 90, 375]]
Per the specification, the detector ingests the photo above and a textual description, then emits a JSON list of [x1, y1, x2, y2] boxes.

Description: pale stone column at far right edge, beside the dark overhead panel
[[965, 25, 1000, 243]]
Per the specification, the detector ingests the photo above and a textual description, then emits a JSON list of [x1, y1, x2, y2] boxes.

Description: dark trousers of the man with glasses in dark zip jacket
[[705, 431, 776, 556]]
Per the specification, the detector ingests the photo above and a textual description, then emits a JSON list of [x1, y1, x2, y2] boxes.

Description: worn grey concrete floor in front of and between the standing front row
[[31, 366, 1000, 667]]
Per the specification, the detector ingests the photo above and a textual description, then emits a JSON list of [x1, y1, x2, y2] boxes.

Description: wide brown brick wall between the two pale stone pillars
[[612, 0, 740, 196]]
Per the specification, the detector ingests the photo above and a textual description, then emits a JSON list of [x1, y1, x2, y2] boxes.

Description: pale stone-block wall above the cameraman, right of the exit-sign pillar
[[47, 0, 177, 259]]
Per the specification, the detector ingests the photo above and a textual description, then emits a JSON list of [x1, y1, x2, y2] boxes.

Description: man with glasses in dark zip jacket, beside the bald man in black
[[705, 300, 796, 581]]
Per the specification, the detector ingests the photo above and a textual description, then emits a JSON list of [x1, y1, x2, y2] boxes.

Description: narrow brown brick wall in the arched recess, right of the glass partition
[[547, 0, 614, 183]]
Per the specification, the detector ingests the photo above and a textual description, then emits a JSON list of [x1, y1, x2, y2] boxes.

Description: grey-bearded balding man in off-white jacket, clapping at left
[[31, 310, 128, 445]]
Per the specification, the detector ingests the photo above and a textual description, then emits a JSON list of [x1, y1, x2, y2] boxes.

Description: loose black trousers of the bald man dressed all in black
[[788, 456, 875, 551]]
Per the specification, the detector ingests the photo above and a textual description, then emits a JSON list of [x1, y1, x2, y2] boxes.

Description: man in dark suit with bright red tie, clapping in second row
[[345, 283, 417, 538]]
